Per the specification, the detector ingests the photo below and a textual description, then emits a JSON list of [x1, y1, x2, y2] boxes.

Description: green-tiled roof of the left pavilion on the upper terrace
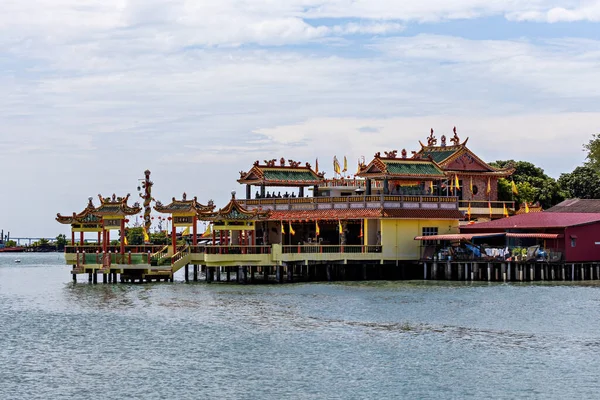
[[238, 158, 323, 186]]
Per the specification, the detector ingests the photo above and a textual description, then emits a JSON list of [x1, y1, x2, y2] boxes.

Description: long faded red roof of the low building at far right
[[460, 211, 600, 232]]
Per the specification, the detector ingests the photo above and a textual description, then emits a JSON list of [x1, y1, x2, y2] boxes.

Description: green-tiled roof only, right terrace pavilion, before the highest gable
[[357, 151, 446, 179]]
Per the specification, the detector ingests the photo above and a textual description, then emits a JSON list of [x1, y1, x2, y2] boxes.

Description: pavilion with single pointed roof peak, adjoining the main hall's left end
[[205, 192, 270, 250]]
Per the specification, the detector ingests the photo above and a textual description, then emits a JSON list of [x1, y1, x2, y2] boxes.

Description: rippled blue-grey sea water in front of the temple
[[0, 253, 600, 399]]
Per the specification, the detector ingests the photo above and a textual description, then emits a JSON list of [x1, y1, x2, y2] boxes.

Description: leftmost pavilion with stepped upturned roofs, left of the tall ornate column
[[56, 194, 141, 254]]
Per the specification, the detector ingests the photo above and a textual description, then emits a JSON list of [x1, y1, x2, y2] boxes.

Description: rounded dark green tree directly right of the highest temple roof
[[490, 160, 565, 208]]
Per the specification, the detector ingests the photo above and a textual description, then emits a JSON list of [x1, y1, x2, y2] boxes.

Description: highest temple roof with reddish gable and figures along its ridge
[[413, 127, 515, 176]]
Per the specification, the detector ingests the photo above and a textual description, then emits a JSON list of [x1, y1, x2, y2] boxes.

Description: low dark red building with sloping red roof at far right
[[460, 212, 600, 262]]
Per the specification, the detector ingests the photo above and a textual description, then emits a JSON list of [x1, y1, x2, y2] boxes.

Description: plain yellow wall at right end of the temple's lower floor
[[381, 219, 458, 260]]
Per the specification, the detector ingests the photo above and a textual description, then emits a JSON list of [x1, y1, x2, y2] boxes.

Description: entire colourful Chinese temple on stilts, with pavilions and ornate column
[[57, 131, 514, 281]]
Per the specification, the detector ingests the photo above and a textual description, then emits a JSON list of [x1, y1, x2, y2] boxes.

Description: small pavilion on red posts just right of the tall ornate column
[[154, 193, 215, 248]]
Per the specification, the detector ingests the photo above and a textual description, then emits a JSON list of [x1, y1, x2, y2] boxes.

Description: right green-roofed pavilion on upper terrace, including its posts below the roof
[[357, 150, 446, 196]]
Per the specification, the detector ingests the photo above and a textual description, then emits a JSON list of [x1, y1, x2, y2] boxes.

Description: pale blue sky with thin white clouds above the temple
[[0, 0, 600, 237]]
